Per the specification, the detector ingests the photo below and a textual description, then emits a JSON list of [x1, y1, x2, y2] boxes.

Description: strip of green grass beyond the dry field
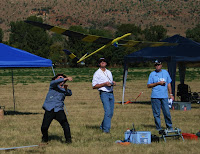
[[0, 67, 200, 85]]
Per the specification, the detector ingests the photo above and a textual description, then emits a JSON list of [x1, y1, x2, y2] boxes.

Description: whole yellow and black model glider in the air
[[25, 20, 177, 63]]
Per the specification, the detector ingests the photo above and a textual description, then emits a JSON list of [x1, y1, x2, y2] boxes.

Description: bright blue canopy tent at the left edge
[[0, 43, 55, 110]]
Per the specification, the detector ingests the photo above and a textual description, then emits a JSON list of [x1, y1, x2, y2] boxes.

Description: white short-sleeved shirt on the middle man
[[92, 68, 113, 92]]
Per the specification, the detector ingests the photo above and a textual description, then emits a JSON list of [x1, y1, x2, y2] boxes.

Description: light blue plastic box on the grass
[[125, 130, 151, 144]]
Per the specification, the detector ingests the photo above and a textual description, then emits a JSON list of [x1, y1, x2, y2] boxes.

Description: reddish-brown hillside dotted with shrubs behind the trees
[[0, 0, 200, 40]]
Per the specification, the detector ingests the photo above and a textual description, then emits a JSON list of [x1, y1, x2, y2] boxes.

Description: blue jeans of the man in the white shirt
[[100, 92, 115, 133]]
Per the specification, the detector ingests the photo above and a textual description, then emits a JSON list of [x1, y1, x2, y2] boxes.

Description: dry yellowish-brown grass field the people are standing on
[[0, 71, 200, 154]]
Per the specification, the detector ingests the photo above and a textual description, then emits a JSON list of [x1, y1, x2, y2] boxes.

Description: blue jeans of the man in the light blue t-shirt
[[151, 98, 172, 130]]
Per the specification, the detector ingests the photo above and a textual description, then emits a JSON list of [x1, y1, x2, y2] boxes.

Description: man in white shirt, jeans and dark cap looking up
[[92, 58, 116, 133]]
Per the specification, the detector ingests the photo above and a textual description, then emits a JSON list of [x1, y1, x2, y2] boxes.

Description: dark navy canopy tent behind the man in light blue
[[122, 35, 200, 103]]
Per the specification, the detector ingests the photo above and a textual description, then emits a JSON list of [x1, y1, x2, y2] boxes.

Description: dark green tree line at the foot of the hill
[[0, 16, 200, 66]]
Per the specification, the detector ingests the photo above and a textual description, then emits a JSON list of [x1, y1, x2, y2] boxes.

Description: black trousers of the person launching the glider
[[41, 109, 71, 142]]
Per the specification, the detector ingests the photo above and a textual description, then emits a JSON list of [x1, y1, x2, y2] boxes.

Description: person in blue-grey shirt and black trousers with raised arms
[[41, 74, 72, 143]]
